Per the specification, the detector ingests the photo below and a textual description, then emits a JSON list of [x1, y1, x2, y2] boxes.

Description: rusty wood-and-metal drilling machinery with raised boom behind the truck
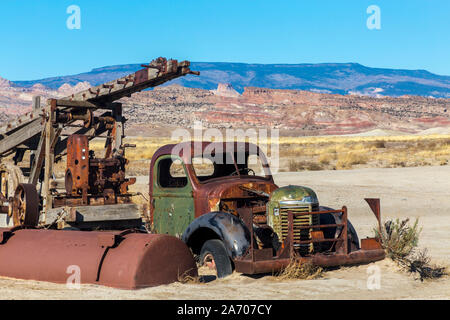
[[0, 58, 199, 226]]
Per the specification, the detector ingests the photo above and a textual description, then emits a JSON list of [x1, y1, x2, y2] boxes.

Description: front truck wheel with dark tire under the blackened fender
[[200, 239, 233, 278]]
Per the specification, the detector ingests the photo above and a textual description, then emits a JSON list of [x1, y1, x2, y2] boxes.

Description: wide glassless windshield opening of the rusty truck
[[192, 153, 271, 182]]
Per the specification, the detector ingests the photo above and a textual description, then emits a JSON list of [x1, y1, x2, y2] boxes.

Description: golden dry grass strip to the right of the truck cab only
[[279, 135, 450, 171]]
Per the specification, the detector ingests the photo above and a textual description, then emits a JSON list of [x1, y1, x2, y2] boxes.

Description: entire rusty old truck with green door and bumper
[[149, 142, 385, 277]]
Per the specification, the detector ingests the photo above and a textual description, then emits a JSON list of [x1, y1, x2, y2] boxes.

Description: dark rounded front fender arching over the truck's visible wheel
[[181, 212, 251, 259]]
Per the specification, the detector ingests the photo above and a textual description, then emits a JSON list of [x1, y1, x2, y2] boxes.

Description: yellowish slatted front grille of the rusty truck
[[280, 205, 320, 255]]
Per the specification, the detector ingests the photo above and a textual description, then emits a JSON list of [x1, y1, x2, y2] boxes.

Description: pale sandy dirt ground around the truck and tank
[[0, 166, 450, 300]]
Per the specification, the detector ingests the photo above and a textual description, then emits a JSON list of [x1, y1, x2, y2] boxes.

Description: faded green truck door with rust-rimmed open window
[[152, 155, 194, 237]]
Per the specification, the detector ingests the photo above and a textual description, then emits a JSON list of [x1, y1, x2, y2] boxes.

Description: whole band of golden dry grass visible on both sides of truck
[[84, 135, 450, 175]]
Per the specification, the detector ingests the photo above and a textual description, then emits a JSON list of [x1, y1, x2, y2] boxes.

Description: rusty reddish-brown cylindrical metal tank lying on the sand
[[0, 228, 197, 289]]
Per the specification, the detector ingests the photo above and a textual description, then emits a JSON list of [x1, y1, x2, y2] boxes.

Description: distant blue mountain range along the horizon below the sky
[[10, 62, 450, 98]]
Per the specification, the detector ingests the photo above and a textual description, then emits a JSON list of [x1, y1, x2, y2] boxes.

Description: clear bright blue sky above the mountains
[[0, 0, 450, 80]]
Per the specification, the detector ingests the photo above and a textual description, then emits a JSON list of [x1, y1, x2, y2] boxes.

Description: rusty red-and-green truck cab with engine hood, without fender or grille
[[150, 142, 278, 236]]
